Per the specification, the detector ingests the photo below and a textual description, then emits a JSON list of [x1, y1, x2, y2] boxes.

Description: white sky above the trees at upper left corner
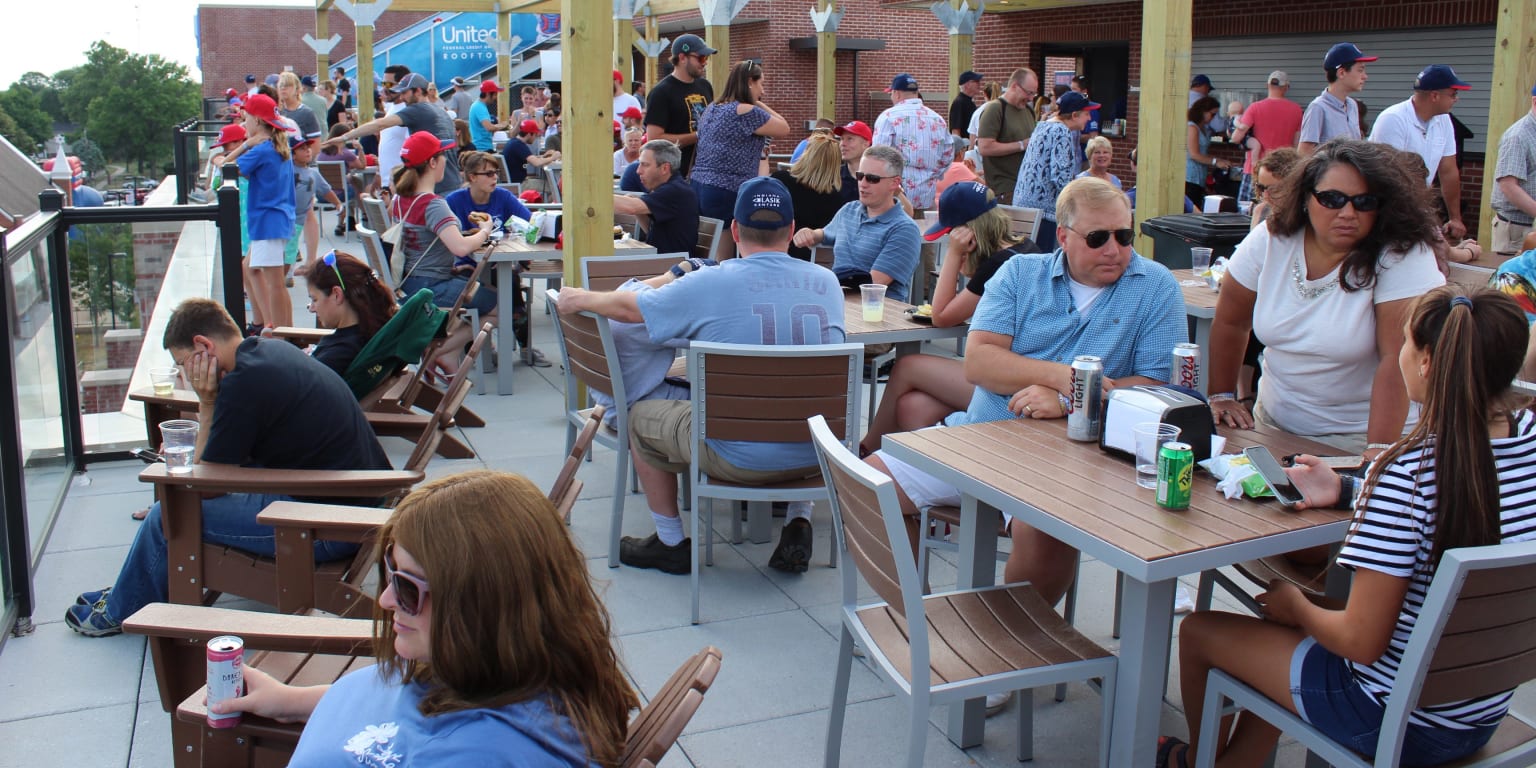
[[0, 0, 315, 89]]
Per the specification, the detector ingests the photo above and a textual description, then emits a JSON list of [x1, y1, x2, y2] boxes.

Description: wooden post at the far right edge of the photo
[[1476, 0, 1536, 247]]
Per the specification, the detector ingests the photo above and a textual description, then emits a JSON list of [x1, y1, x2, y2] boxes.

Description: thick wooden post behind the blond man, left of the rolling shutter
[[1130, 0, 1193, 258]]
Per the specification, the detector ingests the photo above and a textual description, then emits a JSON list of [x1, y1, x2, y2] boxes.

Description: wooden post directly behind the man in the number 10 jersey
[[561, 0, 613, 286]]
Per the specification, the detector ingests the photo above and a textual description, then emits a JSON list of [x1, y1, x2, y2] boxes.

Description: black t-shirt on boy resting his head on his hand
[[203, 338, 390, 504]]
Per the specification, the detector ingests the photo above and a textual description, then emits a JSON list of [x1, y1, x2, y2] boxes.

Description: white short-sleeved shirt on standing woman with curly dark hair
[[1227, 226, 1445, 436]]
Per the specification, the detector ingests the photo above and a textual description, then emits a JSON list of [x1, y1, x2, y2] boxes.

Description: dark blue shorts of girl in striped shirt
[[1290, 637, 1498, 766]]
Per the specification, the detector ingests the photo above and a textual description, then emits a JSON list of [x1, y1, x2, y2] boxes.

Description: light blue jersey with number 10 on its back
[[636, 252, 854, 470]]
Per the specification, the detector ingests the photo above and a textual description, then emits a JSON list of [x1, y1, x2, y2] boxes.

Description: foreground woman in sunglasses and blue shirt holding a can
[[214, 470, 637, 766]]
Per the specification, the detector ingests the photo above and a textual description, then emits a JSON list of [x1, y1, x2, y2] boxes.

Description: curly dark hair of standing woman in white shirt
[[1267, 138, 1438, 290]]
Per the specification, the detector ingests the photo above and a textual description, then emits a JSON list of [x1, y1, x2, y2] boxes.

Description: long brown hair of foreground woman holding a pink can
[[373, 470, 637, 765]]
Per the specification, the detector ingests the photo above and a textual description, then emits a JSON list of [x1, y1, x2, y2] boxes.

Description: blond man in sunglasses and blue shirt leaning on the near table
[[866, 178, 1189, 602]]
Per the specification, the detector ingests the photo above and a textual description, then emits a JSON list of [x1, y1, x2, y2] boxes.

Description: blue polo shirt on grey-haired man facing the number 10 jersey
[[822, 200, 923, 301]]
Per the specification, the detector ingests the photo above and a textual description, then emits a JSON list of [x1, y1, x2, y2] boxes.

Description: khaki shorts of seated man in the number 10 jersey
[[630, 399, 822, 485]]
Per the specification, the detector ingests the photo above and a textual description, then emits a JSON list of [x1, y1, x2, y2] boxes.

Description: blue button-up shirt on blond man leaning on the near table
[[945, 249, 1189, 425]]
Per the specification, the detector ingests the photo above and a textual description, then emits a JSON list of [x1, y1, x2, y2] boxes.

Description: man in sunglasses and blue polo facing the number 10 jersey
[[794, 146, 923, 301]]
